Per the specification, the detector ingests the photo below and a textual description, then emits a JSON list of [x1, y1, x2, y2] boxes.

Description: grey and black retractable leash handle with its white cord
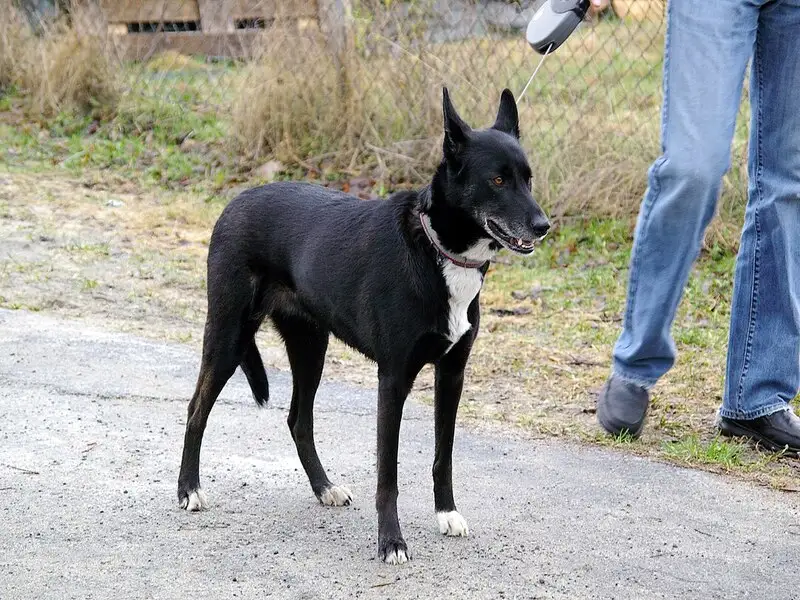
[[517, 0, 590, 104]]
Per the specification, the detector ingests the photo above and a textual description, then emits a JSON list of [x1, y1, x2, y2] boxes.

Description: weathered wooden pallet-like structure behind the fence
[[79, 0, 349, 60]]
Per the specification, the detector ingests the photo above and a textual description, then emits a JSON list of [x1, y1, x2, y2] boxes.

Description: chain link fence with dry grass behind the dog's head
[[15, 0, 747, 214]]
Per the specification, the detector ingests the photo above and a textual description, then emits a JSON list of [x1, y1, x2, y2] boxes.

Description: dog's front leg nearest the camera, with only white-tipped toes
[[375, 371, 411, 564]]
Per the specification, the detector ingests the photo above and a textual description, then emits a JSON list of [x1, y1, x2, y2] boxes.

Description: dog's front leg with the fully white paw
[[433, 334, 473, 536]]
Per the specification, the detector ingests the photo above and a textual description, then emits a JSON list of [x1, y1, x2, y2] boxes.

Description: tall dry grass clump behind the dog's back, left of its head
[[231, 30, 441, 179]]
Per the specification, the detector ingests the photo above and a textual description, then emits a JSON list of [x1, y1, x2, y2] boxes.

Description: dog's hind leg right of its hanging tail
[[272, 313, 353, 506]]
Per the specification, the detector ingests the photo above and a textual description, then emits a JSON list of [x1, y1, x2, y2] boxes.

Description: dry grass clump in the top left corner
[[0, 0, 121, 120]]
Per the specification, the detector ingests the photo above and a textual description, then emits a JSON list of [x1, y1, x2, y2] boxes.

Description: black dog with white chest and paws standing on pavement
[[178, 88, 550, 563]]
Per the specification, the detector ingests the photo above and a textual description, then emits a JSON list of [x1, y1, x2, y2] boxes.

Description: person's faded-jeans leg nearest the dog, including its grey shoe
[[598, 0, 759, 435]]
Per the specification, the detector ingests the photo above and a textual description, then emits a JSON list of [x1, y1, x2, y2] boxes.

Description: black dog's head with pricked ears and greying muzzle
[[432, 88, 550, 254]]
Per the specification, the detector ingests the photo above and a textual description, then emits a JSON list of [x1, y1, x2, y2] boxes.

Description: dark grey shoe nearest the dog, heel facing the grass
[[597, 375, 650, 437]]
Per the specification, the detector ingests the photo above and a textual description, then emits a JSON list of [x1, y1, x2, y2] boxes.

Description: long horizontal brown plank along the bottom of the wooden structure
[[114, 29, 264, 60]]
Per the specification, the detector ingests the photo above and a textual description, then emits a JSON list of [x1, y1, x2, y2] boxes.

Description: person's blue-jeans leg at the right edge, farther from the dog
[[720, 0, 800, 446]]
